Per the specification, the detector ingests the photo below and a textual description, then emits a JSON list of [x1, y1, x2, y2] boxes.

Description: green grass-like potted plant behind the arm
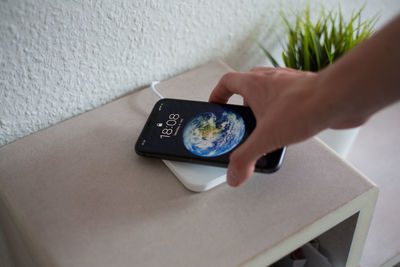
[[250, 5, 378, 72]]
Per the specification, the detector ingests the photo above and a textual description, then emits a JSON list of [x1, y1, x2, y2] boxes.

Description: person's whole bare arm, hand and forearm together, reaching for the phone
[[209, 15, 400, 186]]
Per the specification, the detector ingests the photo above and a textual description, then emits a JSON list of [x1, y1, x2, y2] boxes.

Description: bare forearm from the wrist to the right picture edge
[[316, 16, 400, 127]]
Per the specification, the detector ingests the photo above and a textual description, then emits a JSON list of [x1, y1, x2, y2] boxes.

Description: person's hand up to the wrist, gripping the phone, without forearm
[[209, 67, 346, 186]]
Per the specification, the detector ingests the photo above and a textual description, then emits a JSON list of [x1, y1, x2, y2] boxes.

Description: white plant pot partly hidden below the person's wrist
[[317, 127, 360, 158]]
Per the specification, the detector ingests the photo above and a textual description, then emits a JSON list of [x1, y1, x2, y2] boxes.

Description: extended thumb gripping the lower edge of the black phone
[[227, 127, 268, 187]]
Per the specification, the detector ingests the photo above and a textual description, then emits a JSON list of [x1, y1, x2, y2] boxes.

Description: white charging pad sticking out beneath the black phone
[[163, 160, 226, 192]]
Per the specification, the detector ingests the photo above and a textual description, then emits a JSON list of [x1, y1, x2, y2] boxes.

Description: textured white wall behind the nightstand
[[0, 0, 399, 146]]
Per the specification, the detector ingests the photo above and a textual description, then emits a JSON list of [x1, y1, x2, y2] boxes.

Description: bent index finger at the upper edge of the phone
[[208, 72, 247, 104]]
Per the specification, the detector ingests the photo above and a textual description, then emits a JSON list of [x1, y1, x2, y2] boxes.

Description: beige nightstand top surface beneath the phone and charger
[[0, 62, 375, 267]]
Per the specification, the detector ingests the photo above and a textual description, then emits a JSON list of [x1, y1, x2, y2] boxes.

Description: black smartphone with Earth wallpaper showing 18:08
[[135, 98, 285, 173]]
